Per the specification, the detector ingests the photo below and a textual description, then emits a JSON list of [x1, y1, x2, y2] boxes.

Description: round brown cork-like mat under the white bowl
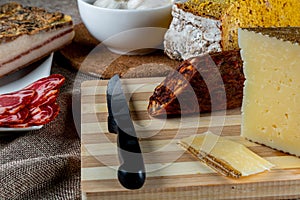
[[59, 23, 180, 79]]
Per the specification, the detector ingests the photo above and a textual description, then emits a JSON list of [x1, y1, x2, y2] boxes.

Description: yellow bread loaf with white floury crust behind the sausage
[[164, 0, 300, 60]]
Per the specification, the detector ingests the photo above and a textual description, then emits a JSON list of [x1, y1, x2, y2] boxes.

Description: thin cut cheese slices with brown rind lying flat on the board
[[179, 132, 273, 178]]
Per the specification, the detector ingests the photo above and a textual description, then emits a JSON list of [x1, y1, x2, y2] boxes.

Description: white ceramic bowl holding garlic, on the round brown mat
[[77, 0, 172, 55]]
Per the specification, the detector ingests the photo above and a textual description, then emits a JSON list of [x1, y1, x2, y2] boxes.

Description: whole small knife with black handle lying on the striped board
[[106, 75, 146, 189]]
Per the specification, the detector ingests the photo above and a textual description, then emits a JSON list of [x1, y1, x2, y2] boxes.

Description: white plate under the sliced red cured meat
[[0, 53, 53, 132]]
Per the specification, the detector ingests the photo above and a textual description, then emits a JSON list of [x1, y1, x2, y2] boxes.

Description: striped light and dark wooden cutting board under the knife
[[81, 78, 300, 200]]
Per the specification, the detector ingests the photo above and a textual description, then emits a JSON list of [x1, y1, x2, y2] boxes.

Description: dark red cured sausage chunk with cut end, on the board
[[148, 50, 245, 117]]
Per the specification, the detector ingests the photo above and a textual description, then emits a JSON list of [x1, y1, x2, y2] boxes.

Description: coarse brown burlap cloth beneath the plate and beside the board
[[0, 57, 94, 200]]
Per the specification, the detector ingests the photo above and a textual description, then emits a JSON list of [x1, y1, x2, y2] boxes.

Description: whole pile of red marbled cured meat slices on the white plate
[[0, 74, 65, 128]]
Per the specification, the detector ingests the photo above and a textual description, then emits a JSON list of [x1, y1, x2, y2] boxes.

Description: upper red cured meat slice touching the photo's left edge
[[0, 89, 35, 116]]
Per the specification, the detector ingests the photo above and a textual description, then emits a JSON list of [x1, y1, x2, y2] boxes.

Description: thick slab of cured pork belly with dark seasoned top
[[0, 2, 74, 77]]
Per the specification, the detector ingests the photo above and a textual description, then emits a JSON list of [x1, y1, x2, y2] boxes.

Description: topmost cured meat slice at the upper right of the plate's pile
[[24, 74, 65, 107]]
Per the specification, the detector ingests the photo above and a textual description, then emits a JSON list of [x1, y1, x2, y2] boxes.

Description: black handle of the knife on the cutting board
[[118, 128, 146, 189]]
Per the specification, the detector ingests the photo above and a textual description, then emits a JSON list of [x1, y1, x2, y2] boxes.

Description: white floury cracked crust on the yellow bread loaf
[[164, 4, 221, 60]]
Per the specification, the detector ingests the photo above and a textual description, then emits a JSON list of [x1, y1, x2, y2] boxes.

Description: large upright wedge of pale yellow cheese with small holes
[[239, 27, 300, 156]]
